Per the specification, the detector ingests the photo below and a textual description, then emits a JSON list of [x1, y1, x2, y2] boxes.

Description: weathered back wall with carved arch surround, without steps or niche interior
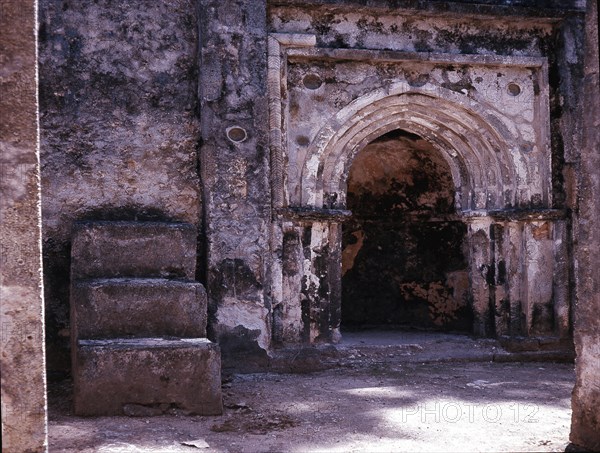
[[39, 0, 583, 370]]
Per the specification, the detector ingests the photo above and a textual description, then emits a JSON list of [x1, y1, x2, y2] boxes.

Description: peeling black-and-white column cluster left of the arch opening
[[273, 207, 350, 344]]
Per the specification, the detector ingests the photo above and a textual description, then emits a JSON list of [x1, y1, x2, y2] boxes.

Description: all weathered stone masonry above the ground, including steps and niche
[[0, 0, 600, 451]]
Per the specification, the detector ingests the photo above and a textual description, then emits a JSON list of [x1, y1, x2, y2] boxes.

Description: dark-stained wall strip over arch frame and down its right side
[[269, 0, 585, 215]]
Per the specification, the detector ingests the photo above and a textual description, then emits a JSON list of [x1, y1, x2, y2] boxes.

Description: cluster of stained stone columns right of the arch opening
[[467, 214, 570, 338]]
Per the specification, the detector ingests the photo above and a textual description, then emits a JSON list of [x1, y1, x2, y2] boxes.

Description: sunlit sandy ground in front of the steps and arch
[[49, 336, 575, 453]]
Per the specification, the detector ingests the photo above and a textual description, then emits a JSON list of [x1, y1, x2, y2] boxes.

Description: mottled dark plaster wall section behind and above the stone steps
[[39, 0, 202, 370]]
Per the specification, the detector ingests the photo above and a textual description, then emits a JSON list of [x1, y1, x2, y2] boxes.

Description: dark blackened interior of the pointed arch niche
[[342, 130, 473, 332]]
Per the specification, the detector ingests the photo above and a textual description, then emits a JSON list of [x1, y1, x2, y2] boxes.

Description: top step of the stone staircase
[[71, 221, 197, 280]]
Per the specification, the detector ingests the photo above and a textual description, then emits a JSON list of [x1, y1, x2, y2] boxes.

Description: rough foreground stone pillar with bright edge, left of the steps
[[0, 0, 47, 452]]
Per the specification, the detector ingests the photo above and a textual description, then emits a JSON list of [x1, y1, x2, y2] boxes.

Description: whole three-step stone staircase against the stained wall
[[71, 221, 222, 416]]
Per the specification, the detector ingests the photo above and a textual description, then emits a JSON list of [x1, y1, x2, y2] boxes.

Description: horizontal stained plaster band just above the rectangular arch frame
[[269, 2, 549, 55]]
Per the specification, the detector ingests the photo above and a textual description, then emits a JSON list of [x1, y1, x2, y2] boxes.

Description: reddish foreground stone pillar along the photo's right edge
[[571, 0, 600, 451]]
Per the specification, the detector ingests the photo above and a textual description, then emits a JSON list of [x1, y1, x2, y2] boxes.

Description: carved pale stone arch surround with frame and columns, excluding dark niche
[[268, 1, 581, 343]]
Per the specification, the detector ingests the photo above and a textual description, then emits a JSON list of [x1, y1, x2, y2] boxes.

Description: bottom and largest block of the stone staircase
[[73, 338, 223, 415]]
